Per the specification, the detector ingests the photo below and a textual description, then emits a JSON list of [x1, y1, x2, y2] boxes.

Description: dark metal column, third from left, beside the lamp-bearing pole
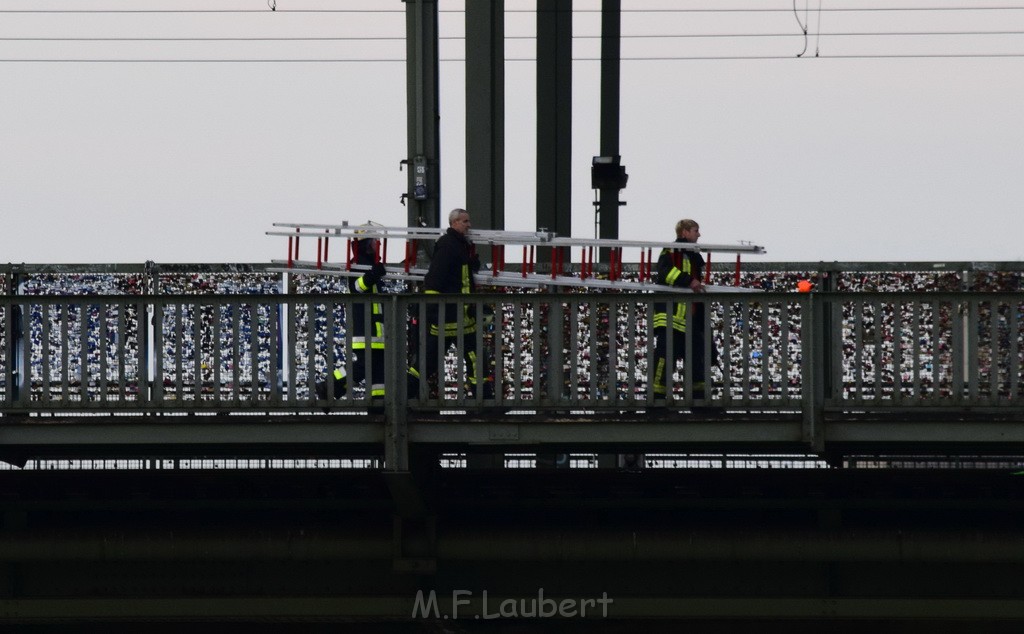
[[537, 0, 572, 237]]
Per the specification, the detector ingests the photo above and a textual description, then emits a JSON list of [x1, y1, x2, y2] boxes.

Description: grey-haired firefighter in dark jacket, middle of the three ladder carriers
[[423, 209, 494, 398]]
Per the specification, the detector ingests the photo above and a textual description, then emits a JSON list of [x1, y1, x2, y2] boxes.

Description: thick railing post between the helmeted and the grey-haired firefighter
[[381, 295, 407, 472]]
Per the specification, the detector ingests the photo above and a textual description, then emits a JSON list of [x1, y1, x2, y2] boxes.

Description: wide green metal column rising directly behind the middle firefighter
[[466, 0, 505, 229]]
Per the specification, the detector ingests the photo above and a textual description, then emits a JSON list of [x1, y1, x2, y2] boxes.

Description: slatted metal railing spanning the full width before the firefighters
[[0, 291, 1024, 413]]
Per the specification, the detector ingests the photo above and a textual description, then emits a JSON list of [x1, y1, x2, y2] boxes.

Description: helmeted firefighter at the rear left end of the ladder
[[316, 233, 387, 399]]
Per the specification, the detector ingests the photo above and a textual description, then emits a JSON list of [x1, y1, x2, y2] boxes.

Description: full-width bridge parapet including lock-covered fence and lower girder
[[0, 263, 1024, 462]]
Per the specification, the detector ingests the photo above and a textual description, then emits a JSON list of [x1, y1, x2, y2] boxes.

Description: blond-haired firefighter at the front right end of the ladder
[[654, 219, 707, 398]]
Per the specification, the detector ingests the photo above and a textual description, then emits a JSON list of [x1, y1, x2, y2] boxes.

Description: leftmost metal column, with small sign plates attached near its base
[[403, 0, 441, 226]]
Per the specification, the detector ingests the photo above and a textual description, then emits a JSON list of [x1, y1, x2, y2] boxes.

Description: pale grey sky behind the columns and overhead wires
[[0, 0, 1024, 262]]
